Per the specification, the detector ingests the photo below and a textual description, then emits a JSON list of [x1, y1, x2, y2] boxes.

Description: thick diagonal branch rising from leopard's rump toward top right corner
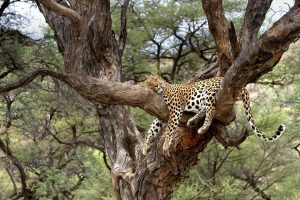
[[217, 5, 300, 123]]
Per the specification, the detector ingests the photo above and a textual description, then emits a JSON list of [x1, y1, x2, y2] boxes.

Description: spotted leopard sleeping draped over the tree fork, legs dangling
[[143, 75, 286, 154]]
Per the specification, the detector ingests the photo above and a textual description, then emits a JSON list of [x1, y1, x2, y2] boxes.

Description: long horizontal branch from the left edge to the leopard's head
[[0, 69, 169, 120]]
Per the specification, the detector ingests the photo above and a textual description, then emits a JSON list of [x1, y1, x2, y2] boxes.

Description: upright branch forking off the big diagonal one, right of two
[[240, 0, 272, 49]]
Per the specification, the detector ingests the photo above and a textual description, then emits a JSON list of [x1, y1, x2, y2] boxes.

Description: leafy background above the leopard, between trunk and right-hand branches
[[112, 0, 245, 82]]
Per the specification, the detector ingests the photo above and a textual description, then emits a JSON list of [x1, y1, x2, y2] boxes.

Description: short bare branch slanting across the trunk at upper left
[[38, 0, 81, 26]]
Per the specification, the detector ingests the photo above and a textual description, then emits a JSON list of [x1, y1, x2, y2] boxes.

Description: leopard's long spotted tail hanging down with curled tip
[[241, 88, 285, 141]]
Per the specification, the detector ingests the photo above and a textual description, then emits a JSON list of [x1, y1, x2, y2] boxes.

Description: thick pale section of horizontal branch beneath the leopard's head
[[69, 76, 169, 120]]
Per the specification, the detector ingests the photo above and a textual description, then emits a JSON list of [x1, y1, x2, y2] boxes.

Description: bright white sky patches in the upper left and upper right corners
[[2, 0, 294, 39]]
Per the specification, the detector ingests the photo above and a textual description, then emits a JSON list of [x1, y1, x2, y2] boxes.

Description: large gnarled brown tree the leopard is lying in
[[0, 0, 300, 199]]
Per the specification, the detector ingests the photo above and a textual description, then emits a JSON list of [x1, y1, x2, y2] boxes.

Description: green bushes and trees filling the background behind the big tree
[[0, 0, 300, 200]]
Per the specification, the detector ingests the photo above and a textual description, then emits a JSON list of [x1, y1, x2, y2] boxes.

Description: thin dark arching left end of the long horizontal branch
[[0, 69, 69, 93]]
